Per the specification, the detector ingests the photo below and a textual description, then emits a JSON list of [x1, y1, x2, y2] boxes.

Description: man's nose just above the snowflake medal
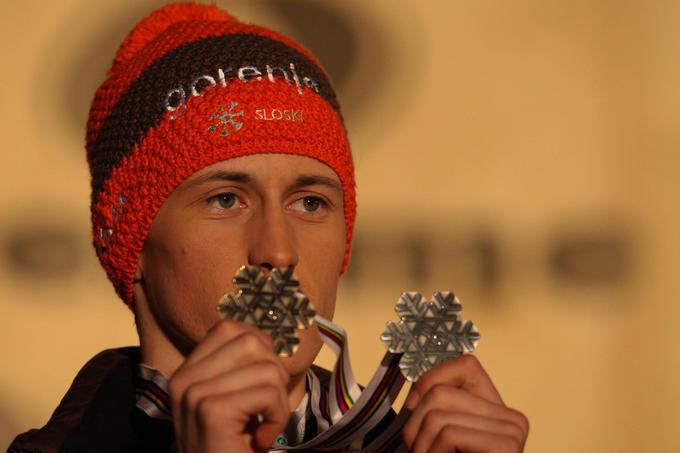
[[248, 209, 298, 270]]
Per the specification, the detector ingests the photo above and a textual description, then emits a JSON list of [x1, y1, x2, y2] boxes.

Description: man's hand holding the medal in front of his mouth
[[169, 321, 290, 453]]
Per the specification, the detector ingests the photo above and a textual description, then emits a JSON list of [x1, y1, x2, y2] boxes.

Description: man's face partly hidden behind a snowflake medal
[[140, 154, 345, 375]]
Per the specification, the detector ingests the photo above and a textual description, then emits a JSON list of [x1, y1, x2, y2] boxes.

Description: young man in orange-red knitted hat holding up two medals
[[10, 4, 528, 453]]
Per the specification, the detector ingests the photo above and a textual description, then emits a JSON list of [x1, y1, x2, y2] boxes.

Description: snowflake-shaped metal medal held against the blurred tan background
[[380, 291, 479, 382]]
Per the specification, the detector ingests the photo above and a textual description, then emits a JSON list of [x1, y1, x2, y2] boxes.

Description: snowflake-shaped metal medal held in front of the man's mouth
[[217, 266, 316, 357]]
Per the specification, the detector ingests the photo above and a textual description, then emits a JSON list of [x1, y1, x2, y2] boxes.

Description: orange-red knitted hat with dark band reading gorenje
[[87, 4, 356, 304]]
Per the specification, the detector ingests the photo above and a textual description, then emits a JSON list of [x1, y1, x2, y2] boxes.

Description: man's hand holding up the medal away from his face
[[403, 355, 529, 453]]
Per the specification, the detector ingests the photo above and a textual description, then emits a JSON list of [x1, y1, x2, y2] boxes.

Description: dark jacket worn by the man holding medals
[[8, 347, 395, 453]]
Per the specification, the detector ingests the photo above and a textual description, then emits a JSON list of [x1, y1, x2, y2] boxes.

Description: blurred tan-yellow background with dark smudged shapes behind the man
[[0, 0, 680, 453]]
